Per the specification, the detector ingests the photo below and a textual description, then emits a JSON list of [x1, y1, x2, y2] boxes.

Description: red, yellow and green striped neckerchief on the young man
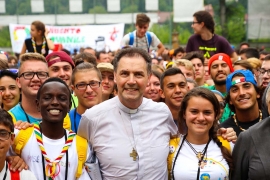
[[34, 123, 76, 179]]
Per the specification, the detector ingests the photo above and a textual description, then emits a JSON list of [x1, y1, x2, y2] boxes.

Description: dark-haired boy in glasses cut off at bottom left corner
[[0, 109, 36, 180]]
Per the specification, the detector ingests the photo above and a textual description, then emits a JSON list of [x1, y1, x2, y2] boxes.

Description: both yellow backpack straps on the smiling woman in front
[[167, 136, 231, 179]]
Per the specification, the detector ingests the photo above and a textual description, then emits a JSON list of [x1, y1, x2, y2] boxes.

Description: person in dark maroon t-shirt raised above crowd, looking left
[[186, 11, 237, 61]]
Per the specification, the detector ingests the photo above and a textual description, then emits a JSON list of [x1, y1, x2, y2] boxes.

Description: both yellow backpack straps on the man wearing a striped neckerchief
[[13, 127, 88, 178]]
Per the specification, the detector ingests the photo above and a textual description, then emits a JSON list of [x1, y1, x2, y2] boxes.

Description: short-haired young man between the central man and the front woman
[[160, 68, 189, 122]]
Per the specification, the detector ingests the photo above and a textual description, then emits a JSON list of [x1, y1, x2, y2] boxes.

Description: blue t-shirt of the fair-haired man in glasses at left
[[9, 103, 41, 123]]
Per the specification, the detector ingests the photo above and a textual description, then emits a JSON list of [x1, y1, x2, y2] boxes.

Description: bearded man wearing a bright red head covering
[[204, 53, 233, 122]]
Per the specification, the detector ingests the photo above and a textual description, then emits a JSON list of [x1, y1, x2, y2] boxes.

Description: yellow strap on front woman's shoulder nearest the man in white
[[167, 137, 180, 179]]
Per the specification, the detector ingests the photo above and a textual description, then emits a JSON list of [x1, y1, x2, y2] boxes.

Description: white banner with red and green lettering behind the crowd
[[9, 23, 124, 53]]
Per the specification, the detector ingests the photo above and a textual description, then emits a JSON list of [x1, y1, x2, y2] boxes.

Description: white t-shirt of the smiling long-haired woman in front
[[173, 137, 233, 180]]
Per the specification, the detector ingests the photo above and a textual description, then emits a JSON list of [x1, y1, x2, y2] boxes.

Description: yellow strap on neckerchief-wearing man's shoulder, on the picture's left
[[13, 127, 34, 156]]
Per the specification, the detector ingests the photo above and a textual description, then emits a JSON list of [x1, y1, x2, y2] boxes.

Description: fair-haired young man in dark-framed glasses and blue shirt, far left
[[9, 53, 49, 123]]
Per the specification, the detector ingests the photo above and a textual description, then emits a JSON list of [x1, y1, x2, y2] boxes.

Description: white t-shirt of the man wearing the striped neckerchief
[[12, 129, 91, 180]]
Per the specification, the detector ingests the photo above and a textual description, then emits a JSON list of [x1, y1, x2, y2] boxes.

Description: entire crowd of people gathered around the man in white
[[0, 11, 270, 180]]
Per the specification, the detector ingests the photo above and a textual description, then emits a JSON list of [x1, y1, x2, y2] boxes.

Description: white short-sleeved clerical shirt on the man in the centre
[[78, 97, 178, 180]]
